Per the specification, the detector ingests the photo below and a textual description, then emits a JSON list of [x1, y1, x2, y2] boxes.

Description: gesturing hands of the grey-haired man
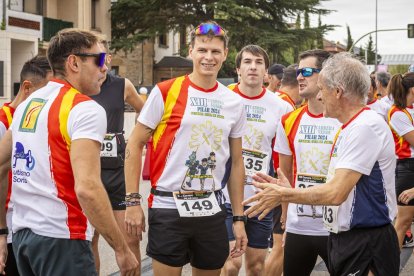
[[243, 169, 291, 220]]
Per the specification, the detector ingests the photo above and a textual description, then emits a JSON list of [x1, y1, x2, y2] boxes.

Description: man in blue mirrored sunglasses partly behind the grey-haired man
[[274, 50, 340, 276]]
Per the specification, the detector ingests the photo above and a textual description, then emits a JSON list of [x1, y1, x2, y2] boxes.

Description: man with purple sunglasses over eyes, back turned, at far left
[[0, 29, 139, 275]]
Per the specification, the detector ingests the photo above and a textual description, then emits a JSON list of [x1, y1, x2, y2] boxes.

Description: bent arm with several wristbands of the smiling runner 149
[[125, 122, 154, 240]]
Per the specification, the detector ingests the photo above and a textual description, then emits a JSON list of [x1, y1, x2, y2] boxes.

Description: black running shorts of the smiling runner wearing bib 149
[[147, 205, 229, 270]]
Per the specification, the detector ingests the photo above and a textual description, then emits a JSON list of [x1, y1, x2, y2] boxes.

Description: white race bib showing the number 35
[[242, 149, 270, 176]]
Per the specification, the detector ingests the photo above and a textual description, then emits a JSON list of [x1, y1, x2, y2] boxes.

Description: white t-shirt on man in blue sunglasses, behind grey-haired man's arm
[[275, 106, 341, 236]]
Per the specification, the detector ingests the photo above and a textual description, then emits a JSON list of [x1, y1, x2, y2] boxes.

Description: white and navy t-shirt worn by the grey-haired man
[[324, 109, 397, 232]]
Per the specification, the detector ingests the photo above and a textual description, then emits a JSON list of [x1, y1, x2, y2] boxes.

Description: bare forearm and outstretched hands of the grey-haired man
[[243, 169, 362, 219]]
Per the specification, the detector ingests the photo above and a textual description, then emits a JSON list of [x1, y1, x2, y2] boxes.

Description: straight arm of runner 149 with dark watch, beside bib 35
[[227, 138, 247, 258]]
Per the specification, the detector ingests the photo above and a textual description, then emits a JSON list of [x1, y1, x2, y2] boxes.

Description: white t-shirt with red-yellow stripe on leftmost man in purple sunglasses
[[11, 80, 106, 240]]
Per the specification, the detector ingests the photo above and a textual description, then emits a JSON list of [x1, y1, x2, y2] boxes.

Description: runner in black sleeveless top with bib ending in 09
[[92, 40, 144, 274]]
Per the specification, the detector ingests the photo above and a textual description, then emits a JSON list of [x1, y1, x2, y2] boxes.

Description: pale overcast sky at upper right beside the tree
[[311, 0, 414, 54]]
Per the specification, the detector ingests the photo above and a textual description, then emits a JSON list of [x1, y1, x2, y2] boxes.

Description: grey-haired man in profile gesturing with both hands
[[246, 52, 400, 276]]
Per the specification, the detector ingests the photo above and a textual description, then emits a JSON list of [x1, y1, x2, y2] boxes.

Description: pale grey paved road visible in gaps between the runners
[[99, 175, 414, 276]]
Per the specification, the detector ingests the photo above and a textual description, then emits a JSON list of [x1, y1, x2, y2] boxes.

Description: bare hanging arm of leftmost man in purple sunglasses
[[70, 139, 138, 275]]
